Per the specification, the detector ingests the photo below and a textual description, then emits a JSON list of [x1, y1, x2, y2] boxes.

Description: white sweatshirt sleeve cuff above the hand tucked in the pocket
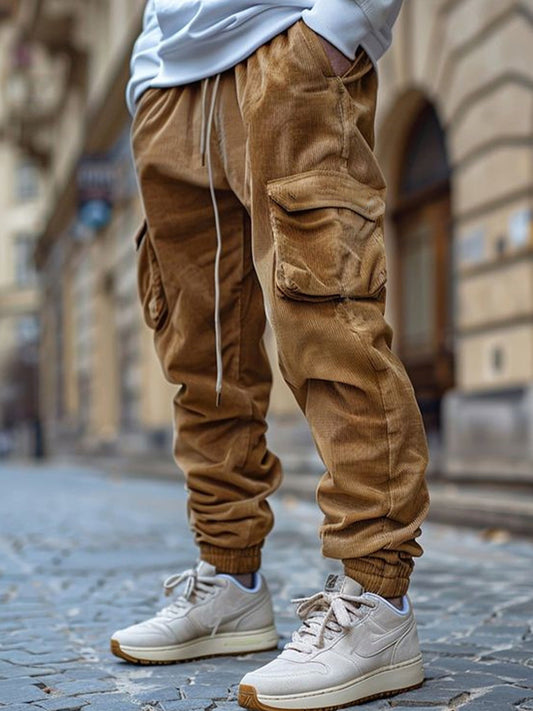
[[302, 0, 372, 59]]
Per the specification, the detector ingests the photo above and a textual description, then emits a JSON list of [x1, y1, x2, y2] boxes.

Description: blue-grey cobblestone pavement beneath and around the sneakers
[[0, 463, 533, 711]]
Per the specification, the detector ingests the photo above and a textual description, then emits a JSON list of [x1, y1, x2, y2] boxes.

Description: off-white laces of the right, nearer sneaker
[[285, 591, 376, 654]]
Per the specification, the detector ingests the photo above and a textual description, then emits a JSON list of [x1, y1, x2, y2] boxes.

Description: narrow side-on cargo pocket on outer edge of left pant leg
[[135, 220, 168, 330]]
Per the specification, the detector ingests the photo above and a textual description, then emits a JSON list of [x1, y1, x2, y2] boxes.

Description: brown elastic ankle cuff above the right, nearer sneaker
[[342, 558, 413, 597]]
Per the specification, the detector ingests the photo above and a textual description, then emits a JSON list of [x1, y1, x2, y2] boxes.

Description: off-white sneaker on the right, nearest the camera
[[239, 575, 424, 711]]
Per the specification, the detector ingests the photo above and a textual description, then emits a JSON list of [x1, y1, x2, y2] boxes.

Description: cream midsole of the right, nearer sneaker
[[257, 655, 424, 709]]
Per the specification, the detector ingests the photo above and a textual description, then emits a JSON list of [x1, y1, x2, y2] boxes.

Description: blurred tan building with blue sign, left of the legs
[[2, 0, 176, 453]]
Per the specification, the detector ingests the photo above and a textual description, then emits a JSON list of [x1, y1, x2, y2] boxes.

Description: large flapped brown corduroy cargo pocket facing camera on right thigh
[[267, 170, 387, 300]]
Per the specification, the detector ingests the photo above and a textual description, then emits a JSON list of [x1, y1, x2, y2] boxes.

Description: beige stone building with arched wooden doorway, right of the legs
[[378, 0, 533, 479]]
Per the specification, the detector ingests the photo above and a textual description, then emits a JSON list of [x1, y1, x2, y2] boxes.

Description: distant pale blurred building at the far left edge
[[0, 16, 43, 457]]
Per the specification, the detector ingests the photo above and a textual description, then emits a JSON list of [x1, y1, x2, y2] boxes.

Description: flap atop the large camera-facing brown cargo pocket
[[268, 170, 385, 221]]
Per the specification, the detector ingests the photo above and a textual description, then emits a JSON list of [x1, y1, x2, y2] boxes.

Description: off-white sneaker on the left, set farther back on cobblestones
[[111, 561, 278, 664]]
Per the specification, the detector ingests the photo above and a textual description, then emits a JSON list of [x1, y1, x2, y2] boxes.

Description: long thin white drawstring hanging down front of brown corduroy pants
[[200, 74, 224, 407]]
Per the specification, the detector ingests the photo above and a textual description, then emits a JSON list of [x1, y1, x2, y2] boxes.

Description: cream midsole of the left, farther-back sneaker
[[115, 625, 278, 662]]
